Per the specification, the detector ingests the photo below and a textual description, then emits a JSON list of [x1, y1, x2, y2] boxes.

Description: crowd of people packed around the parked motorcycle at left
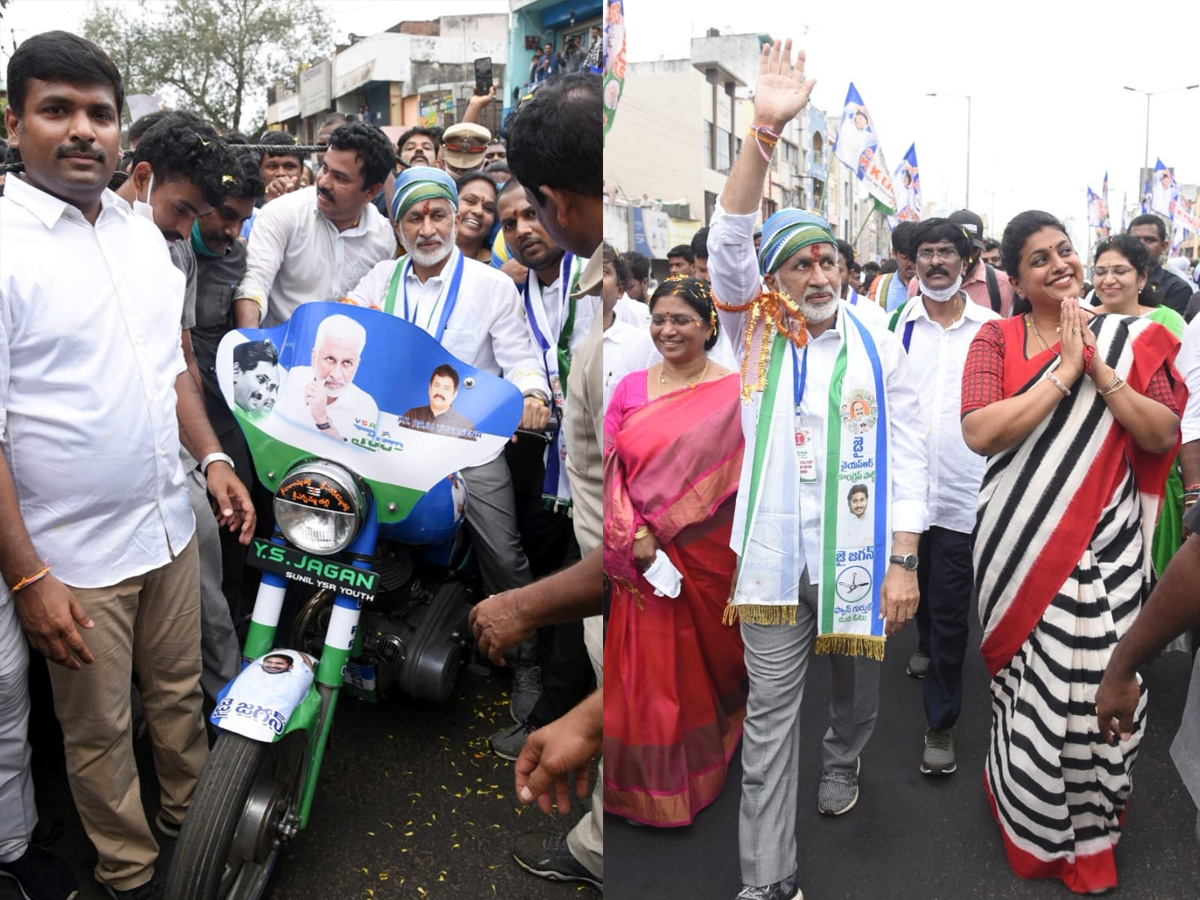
[[0, 24, 602, 900]]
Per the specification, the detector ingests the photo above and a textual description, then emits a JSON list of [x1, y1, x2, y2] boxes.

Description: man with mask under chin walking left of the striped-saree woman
[[889, 218, 1000, 775]]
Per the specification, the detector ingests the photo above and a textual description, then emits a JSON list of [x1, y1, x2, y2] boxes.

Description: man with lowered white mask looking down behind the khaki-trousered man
[[116, 110, 252, 703]]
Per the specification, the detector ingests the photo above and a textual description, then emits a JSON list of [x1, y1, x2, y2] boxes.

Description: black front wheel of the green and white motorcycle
[[164, 732, 305, 900]]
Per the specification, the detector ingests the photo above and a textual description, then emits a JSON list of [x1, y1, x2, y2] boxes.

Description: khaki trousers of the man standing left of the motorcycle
[[50, 538, 209, 890]]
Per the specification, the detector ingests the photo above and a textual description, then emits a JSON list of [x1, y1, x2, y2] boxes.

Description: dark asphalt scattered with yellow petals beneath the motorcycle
[[27, 668, 599, 900]]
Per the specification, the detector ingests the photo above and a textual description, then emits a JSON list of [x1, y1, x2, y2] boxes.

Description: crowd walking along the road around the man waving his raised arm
[[602, 41, 1200, 900]]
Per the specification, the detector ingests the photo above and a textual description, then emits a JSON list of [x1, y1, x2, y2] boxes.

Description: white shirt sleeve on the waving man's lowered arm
[[872, 331, 929, 534]]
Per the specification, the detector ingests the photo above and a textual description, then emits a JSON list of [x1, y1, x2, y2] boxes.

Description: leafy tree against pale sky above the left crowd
[[83, 0, 331, 131]]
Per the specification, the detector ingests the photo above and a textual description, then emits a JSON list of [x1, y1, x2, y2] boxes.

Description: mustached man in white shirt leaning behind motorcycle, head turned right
[[234, 122, 396, 328]]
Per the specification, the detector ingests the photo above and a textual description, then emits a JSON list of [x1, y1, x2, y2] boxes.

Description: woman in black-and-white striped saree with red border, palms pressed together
[[962, 211, 1187, 893]]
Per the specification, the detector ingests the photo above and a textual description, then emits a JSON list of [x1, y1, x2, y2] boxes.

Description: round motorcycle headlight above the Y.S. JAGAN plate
[[272, 460, 367, 554]]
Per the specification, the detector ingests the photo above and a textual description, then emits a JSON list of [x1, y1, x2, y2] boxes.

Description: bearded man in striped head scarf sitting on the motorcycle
[[346, 166, 550, 619]]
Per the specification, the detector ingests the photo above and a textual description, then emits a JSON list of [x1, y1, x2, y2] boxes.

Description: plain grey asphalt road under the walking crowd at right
[[605, 622, 1200, 900]]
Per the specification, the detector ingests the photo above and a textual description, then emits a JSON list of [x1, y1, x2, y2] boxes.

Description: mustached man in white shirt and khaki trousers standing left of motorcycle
[[0, 31, 253, 900]]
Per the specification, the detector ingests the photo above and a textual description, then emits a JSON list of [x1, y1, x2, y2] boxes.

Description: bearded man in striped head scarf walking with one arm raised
[[708, 41, 928, 900]]
